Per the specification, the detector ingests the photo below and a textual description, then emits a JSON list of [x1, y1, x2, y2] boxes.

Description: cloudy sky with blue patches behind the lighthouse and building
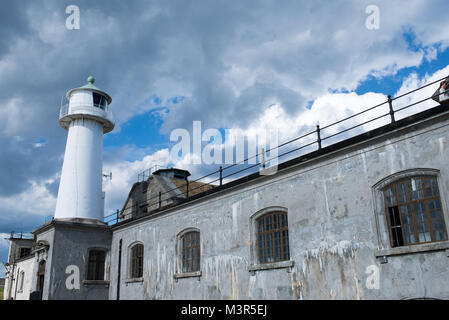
[[0, 0, 449, 276]]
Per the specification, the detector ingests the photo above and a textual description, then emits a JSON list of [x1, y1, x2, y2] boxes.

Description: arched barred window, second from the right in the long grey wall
[[256, 212, 290, 263]]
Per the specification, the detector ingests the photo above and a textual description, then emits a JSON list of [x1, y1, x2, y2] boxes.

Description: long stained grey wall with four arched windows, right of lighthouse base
[[109, 110, 449, 299]]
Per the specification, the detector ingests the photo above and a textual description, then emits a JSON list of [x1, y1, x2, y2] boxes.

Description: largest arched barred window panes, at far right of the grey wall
[[384, 176, 447, 247]]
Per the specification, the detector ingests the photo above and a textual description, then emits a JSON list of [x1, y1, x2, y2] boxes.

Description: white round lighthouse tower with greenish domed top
[[55, 77, 114, 222]]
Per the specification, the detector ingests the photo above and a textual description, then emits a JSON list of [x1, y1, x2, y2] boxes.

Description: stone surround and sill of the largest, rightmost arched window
[[371, 168, 449, 263]]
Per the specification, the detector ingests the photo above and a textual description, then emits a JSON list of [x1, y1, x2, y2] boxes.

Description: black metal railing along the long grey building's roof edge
[[104, 77, 449, 225]]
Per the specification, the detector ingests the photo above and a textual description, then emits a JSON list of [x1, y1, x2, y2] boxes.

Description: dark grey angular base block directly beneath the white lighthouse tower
[[30, 218, 112, 300]]
